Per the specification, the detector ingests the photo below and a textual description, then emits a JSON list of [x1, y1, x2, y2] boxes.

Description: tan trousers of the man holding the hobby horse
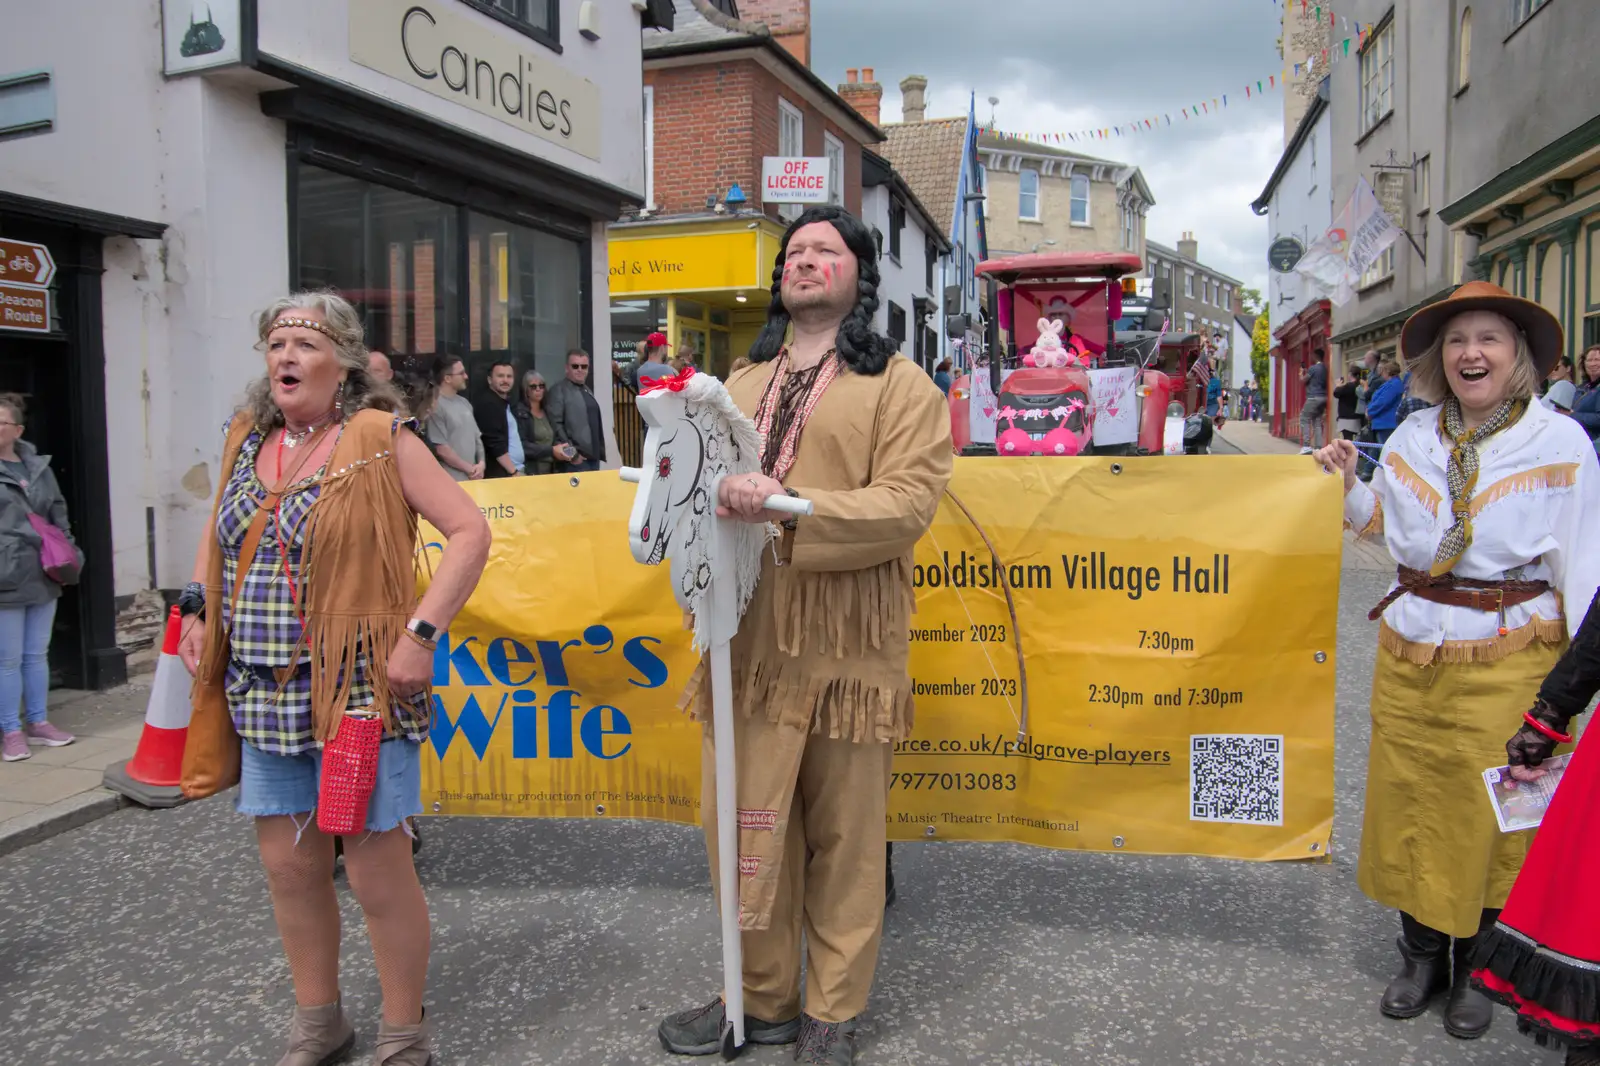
[[701, 714, 894, 1021]]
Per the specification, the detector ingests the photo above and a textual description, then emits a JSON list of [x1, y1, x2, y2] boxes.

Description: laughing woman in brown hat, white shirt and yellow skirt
[[1315, 282, 1600, 1039]]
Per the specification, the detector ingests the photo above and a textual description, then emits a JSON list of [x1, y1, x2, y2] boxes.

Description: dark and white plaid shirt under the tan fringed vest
[[216, 419, 429, 755]]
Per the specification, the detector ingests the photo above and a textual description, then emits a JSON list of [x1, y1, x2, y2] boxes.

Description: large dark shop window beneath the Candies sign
[[291, 165, 584, 393]]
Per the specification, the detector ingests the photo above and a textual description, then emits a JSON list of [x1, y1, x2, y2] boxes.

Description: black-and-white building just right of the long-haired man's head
[[861, 150, 950, 373]]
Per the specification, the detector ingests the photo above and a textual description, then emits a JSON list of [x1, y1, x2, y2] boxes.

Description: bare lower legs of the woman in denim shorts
[[256, 818, 429, 1026]]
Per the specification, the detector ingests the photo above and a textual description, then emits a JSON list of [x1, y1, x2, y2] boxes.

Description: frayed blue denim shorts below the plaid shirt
[[234, 736, 422, 832]]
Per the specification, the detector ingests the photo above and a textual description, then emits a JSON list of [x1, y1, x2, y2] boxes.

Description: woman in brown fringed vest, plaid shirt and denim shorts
[[181, 293, 490, 1066]]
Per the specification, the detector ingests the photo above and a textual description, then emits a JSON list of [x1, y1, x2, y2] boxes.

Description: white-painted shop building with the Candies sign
[[0, 0, 659, 687]]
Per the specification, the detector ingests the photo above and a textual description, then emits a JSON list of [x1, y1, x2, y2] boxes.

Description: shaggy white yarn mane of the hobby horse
[[675, 375, 778, 651]]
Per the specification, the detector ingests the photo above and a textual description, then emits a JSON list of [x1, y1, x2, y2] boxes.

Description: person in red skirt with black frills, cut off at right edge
[[1472, 585, 1600, 1066]]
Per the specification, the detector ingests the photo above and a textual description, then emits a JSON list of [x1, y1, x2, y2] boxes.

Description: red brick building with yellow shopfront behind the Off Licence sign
[[610, 0, 883, 376]]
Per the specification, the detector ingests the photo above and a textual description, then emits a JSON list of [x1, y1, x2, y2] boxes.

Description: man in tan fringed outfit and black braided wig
[[659, 206, 954, 1066]]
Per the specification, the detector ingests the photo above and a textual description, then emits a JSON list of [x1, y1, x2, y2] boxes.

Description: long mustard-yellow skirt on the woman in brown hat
[[1357, 627, 1566, 936]]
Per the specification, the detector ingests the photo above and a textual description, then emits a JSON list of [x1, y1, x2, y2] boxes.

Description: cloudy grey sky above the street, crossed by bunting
[[811, 0, 1283, 291]]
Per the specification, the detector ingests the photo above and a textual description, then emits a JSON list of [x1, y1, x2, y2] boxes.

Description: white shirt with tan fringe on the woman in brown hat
[[1344, 403, 1600, 666]]
